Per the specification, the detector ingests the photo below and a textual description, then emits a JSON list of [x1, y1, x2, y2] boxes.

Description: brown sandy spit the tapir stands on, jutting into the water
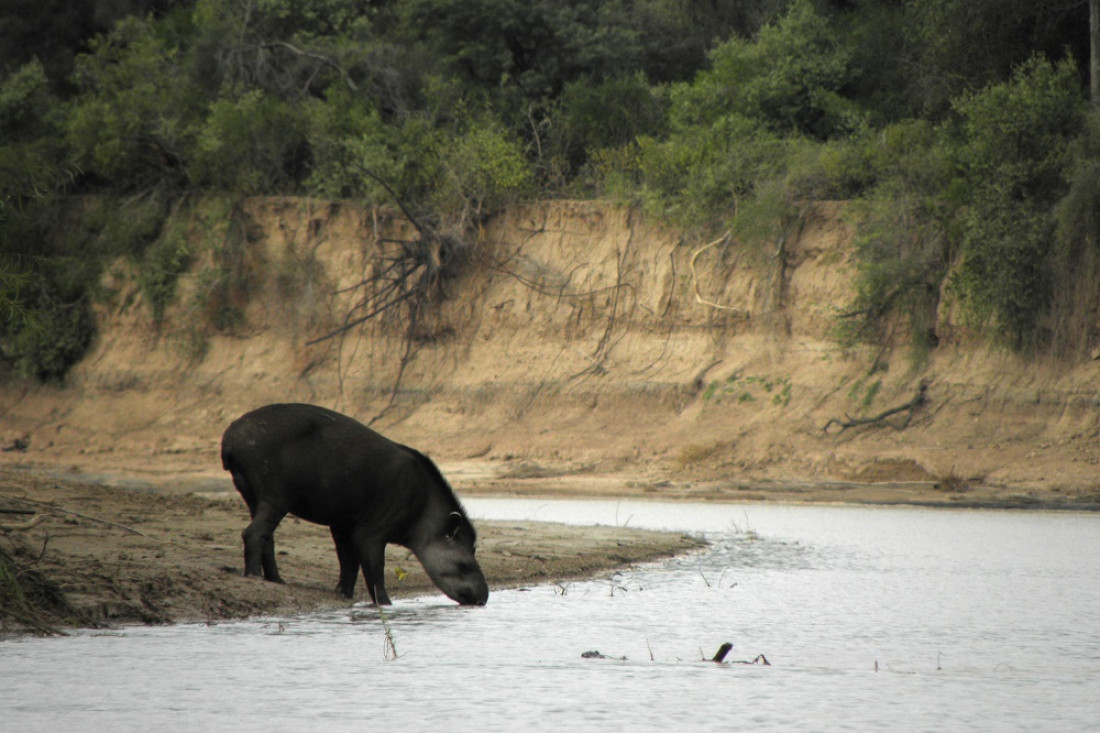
[[0, 470, 702, 632]]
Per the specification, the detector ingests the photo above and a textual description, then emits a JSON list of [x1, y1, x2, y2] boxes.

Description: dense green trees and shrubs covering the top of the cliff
[[0, 0, 1100, 379]]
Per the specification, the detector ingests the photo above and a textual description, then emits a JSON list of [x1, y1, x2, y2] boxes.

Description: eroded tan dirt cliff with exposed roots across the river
[[0, 198, 1100, 505]]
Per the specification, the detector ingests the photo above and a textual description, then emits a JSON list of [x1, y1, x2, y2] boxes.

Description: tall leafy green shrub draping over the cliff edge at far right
[[953, 56, 1085, 350]]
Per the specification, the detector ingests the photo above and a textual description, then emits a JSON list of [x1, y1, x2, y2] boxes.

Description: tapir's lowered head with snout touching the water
[[416, 512, 488, 605]]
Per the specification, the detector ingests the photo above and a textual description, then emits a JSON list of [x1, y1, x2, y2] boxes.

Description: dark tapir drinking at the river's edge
[[221, 404, 488, 605]]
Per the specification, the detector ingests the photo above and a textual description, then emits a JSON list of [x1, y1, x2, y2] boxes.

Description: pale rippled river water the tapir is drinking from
[[0, 499, 1100, 731]]
